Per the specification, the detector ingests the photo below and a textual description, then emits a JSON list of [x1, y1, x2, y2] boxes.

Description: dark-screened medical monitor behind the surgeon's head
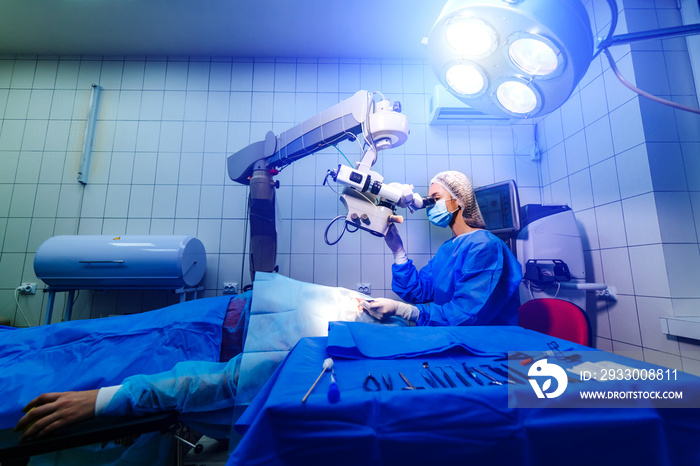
[[474, 180, 520, 235]]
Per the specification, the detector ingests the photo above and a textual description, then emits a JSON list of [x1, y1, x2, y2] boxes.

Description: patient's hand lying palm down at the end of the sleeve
[[15, 390, 99, 441]]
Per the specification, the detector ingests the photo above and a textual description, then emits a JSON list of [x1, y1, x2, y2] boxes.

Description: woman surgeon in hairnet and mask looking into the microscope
[[362, 171, 522, 325]]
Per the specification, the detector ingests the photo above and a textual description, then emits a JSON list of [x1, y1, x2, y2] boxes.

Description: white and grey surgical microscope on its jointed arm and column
[[227, 90, 434, 277]]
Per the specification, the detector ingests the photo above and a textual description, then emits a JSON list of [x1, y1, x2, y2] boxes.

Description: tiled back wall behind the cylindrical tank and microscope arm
[[0, 57, 541, 326]]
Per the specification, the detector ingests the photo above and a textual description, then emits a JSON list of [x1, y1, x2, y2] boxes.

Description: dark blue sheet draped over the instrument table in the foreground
[[227, 325, 700, 466]]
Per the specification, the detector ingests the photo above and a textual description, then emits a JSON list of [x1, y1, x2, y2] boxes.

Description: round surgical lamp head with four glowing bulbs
[[428, 0, 593, 118]]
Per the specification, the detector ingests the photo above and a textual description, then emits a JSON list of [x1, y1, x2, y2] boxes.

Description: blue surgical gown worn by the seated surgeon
[[391, 230, 522, 325]]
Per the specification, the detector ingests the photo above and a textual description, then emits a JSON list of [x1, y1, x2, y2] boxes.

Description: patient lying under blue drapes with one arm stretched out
[[5, 273, 388, 448]]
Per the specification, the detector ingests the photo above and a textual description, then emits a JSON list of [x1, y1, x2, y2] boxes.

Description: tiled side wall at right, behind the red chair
[[537, 0, 700, 373]]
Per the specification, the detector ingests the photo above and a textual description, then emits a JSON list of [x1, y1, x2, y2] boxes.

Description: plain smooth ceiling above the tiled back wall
[[0, 0, 445, 59]]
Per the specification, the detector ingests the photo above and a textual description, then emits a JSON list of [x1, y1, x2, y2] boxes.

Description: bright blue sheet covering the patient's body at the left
[[0, 296, 230, 428]]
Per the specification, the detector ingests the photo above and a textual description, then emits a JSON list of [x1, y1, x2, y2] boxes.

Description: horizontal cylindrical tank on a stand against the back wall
[[34, 235, 206, 289]]
